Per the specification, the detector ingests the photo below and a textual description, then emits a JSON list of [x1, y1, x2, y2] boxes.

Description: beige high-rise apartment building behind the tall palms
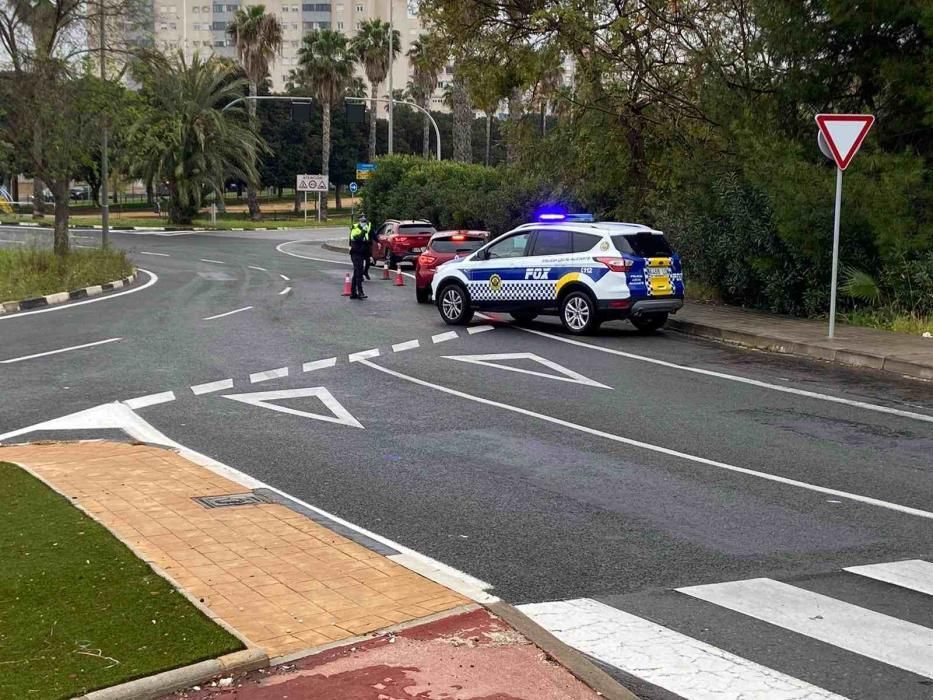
[[153, 0, 450, 99]]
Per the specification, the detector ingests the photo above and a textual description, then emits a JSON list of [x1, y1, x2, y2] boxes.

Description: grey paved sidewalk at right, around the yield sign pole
[[667, 303, 933, 380]]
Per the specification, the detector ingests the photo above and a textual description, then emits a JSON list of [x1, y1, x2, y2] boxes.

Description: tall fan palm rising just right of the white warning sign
[[295, 29, 356, 219]]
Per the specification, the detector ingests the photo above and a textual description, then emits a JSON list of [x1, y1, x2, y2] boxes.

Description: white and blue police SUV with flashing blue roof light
[[432, 212, 684, 334]]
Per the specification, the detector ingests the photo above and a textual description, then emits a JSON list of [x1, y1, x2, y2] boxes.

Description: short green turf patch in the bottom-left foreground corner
[[0, 462, 242, 700]]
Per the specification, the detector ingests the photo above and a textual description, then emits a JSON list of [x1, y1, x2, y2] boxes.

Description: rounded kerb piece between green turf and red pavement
[[75, 648, 269, 700]]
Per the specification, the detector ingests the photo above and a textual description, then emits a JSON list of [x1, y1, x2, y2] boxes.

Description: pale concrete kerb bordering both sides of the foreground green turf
[[1, 456, 269, 700]]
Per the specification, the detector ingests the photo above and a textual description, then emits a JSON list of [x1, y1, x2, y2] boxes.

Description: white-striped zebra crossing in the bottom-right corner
[[519, 559, 933, 700]]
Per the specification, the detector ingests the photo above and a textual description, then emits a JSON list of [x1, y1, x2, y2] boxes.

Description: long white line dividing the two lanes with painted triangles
[[362, 360, 933, 520]]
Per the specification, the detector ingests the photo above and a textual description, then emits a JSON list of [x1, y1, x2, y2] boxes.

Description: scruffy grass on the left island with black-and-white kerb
[[0, 248, 133, 301]]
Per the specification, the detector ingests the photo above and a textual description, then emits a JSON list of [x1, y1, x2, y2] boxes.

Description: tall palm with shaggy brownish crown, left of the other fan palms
[[227, 5, 282, 219]]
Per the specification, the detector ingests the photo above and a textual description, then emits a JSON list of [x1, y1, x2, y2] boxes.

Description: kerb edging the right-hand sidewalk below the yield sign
[[667, 318, 933, 381]]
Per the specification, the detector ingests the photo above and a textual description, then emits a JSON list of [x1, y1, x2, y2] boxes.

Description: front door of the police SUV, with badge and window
[[469, 231, 533, 309]]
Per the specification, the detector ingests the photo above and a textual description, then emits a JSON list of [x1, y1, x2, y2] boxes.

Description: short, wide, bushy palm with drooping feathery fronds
[[134, 51, 265, 224]]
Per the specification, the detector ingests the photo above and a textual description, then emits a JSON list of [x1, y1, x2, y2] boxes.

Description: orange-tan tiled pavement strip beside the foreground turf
[[0, 442, 470, 656]]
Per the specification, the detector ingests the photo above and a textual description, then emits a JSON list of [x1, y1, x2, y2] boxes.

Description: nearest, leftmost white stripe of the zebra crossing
[[518, 598, 844, 700]]
